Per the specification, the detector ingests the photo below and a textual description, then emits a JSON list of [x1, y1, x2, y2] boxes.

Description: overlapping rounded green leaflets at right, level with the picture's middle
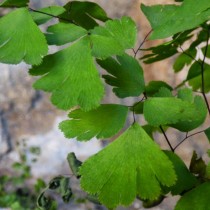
[[144, 89, 207, 131]]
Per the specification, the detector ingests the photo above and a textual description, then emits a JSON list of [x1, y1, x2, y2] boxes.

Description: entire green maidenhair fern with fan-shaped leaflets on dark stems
[[0, 0, 210, 210]]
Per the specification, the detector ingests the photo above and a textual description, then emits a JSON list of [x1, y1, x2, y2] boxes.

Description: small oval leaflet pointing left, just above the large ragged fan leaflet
[[45, 23, 87, 45]]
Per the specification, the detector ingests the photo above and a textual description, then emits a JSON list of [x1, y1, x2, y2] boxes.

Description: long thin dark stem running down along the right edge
[[201, 29, 210, 114]]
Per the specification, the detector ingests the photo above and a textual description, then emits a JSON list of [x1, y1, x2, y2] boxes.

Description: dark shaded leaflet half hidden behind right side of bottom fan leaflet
[[165, 151, 197, 195]]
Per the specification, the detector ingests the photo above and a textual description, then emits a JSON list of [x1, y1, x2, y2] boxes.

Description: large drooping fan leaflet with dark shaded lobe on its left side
[[30, 37, 104, 111]]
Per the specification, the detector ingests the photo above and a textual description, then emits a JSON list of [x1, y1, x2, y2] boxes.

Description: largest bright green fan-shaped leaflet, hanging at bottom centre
[[80, 123, 176, 208]]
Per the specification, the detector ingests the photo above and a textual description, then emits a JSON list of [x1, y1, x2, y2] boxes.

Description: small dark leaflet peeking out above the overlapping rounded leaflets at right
[[145, 81, 173, 96]]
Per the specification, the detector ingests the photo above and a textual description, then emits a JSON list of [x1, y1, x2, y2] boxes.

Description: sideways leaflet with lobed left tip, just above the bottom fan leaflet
[[59, 104, 128, 141]]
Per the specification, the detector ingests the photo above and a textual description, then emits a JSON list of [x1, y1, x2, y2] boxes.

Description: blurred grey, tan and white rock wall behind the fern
[[0, 0, 207, 210]]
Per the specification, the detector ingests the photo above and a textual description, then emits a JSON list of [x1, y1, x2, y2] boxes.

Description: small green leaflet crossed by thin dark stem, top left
[[31, 6, 66, 25]]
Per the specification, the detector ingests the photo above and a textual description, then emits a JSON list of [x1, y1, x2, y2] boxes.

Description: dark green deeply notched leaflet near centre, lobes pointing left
[[97, 54, 145, 98]]
